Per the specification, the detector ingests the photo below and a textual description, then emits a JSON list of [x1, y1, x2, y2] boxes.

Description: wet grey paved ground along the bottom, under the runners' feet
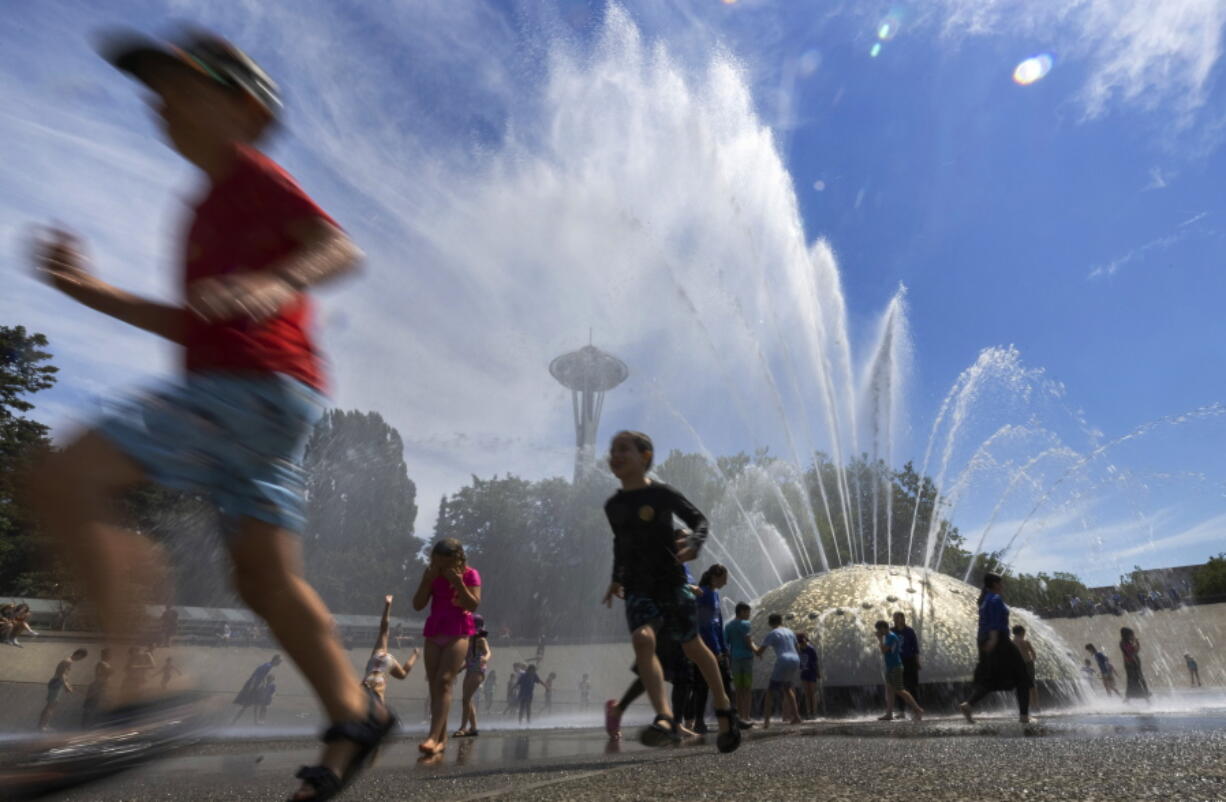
[[31, 715, 1226, 802]]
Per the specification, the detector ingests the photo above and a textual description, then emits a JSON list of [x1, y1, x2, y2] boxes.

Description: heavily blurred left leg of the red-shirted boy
[[29, 432, 154, 704]]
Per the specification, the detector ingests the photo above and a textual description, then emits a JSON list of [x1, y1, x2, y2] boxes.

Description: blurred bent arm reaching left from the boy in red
[[34, 228, 186, 345]]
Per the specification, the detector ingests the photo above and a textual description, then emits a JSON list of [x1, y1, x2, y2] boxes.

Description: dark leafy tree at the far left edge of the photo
[[0, 326, 59, 595]]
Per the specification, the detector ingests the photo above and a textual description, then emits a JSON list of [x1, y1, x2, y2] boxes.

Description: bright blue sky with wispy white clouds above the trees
[[0, 0, 1226, 591]]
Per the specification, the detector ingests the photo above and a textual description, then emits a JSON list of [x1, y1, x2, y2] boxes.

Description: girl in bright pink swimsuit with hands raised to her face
[[413, 537, 481, 755]]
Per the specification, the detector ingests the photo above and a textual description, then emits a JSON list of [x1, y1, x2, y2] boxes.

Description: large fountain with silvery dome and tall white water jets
[[458, 5, 1224, 716]]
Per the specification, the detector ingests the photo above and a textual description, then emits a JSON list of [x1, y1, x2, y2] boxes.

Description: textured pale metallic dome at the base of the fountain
[[752, 565, 1078, 689]]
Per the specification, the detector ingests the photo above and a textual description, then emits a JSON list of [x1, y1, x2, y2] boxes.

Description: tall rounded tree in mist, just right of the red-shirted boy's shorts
[[303, 410, 421, 614]]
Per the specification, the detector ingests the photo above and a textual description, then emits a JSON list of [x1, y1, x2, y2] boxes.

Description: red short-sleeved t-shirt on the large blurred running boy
[[184, 146, 332, 390]]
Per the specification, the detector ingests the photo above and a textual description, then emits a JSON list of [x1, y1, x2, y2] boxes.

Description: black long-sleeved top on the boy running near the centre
[[604, 482, 707, 594]]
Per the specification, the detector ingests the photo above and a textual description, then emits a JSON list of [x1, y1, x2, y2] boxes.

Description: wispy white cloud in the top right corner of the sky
[[942, 0, 1226, 124]]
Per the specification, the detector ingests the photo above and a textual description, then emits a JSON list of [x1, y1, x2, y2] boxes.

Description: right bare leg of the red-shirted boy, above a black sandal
[[229, 517, 367, 798]]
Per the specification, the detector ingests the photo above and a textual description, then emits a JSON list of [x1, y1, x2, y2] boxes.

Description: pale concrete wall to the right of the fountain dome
[[1047, 605, 1226, 690]]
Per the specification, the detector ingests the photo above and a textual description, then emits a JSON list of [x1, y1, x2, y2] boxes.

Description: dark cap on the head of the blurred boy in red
[[97, 29, 282, 119]]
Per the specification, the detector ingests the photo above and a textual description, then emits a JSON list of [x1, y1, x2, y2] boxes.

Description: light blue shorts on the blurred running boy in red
[[97, 373, 325, 536]]
